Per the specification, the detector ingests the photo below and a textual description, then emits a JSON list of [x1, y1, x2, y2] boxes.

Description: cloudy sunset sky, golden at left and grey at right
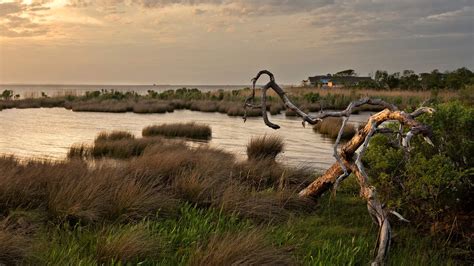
[[0, 0, 474, 85]]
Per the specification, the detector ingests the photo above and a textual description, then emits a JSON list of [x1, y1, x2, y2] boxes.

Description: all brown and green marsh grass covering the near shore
[[0, 112, 469, 265]]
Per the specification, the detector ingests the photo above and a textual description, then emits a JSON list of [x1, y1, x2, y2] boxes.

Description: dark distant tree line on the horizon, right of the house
[[353, 67, 474, 90]]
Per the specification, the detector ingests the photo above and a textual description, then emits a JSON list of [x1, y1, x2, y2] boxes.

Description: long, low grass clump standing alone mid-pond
[[142, 122, 212, 140]]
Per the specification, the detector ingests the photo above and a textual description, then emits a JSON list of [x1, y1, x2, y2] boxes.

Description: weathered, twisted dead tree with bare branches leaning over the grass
[[244, 70, 434, 265]]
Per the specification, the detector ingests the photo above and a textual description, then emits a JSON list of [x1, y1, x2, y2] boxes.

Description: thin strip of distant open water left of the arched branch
[[0, 84, 249, 98]]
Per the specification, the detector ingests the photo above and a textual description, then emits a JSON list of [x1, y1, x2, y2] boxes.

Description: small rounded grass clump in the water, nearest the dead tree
[[247, 135, 285, 160]]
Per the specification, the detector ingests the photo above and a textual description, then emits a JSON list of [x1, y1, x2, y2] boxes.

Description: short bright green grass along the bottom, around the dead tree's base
[[21, 193, 459, 265]]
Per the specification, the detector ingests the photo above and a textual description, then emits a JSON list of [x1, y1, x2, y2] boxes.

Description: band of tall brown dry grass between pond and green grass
[[4, 132, 310, 227]]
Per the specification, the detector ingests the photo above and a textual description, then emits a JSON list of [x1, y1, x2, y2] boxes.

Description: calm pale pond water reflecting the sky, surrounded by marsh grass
[[0, 108, 369, 168]]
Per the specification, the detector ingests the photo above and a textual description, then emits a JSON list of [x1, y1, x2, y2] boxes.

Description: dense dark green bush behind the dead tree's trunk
[[364, 102, 474, 234]]
